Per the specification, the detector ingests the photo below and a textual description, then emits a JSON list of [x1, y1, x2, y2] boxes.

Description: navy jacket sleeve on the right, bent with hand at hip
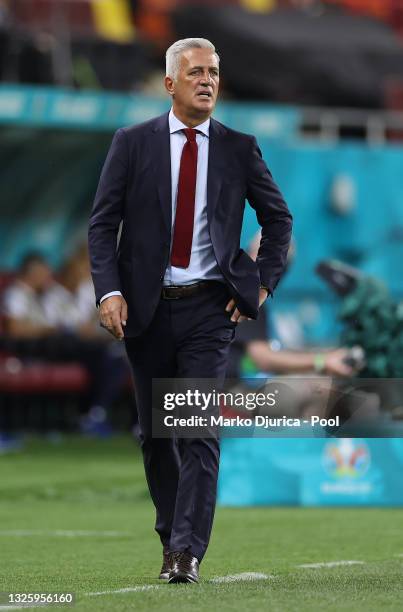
[[246, 137, 292, 295]]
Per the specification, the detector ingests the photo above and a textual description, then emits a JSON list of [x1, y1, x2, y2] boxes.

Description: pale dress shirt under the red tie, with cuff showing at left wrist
[[100, 109, 224, 302]]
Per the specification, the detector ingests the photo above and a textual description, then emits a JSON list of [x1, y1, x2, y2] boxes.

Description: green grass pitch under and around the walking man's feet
[[0, 437, 403, 612]]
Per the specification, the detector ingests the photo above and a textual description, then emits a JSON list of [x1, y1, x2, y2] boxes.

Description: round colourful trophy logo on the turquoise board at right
[[323, 438, 371, 478]]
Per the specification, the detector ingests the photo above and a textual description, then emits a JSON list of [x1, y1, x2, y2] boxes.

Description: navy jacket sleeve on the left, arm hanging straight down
[[88, 129, 129, 304]]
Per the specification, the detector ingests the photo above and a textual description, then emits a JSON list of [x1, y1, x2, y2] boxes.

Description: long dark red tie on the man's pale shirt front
[[171, 128, 197, 268]]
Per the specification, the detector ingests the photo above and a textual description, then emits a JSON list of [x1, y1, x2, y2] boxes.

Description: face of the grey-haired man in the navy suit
[[165, 47, 220, 119]]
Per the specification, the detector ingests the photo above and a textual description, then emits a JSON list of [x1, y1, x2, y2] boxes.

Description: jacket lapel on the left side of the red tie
[[151, 113, 172, 232]]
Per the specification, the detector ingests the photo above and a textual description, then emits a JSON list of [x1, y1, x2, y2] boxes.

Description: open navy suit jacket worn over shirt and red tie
[[89, 113, 292, 337]]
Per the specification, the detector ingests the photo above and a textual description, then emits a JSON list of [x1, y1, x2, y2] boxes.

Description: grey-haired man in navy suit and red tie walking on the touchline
[[89, 38, 292, 583]]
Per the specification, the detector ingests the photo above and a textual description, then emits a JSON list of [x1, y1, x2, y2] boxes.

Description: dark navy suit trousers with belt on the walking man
[[125, 281, 236, 561]]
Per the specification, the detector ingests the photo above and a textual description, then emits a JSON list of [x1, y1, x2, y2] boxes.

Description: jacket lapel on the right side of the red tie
[[207, 119, 226, 226]]
